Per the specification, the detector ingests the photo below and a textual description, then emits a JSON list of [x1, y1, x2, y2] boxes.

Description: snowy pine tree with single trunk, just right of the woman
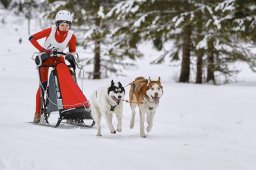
[[47, 0, 137, 79]]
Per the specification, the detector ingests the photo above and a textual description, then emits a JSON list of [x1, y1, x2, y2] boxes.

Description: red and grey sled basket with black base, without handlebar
[[38, 54, 94, 127]]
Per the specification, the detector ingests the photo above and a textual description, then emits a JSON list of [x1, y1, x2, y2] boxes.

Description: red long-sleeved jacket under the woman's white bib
[[29, 27, 76, 53]]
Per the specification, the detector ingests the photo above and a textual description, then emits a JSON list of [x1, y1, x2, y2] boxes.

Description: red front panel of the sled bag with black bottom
[[50, 63, 94, 127]]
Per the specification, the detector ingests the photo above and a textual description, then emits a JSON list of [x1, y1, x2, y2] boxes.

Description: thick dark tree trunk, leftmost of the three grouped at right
[[179, 25, 191, 82]]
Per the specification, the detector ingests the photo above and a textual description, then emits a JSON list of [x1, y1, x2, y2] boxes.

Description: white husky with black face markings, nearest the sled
[[91, 80, 125, 136]]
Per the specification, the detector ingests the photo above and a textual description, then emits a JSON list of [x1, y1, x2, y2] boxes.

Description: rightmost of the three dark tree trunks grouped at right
[[206, 39, 216, 84]]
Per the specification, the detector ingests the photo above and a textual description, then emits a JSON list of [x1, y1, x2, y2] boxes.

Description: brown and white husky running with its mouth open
[[129, 77, 163, 138]]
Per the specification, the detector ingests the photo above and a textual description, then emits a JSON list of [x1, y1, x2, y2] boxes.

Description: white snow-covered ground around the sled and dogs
[[0, 10, 256, 170]]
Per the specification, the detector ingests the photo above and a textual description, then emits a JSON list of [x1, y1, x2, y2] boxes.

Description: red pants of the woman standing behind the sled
[[36, 57, 65, 115]]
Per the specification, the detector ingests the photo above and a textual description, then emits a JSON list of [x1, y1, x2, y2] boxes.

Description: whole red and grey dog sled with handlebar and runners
[[32, 51, 95, 127]]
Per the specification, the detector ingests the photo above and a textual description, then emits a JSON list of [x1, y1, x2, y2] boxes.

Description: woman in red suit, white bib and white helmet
[[29, 10, 76, 123]]
